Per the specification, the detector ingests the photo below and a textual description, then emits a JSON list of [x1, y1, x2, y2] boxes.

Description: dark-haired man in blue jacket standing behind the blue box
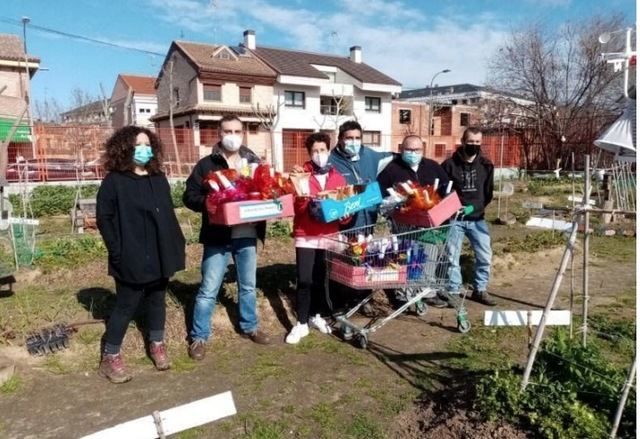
[[329, 120, 392, 229]]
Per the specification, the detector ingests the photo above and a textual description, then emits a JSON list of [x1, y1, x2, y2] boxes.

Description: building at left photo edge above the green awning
[[0, 34, 40, 144]]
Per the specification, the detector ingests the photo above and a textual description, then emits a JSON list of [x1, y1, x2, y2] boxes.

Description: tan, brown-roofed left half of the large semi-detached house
[[152, 41, 276, 161]]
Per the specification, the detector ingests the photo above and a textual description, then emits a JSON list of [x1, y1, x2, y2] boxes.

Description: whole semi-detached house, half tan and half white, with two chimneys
[[153, 30, 401, 170]]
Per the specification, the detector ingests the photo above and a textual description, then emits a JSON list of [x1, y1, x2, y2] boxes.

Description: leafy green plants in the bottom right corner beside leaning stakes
[[474, 330, 636, 439]]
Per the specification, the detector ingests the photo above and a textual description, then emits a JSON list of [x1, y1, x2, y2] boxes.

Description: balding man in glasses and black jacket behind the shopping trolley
[[378, 135, 449, 308]]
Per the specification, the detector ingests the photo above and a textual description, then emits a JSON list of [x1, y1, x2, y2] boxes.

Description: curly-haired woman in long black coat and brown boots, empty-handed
[[96, 126, 185, 383]]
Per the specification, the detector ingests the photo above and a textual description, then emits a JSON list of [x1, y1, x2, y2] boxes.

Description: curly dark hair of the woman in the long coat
[[102, 125, 162, 174]]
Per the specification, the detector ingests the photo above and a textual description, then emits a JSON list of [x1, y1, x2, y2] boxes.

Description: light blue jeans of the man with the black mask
[[447, 220, 491, 293]]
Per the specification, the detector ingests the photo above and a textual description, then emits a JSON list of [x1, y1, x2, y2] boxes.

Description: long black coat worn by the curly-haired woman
[[96, 172, 185, 284]]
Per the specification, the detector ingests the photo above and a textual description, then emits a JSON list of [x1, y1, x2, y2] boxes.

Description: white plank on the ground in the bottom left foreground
[[82, 391, 236, 439]]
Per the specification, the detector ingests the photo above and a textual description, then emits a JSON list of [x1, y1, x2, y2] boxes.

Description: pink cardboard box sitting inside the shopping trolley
[[329, 260, 407, 289]]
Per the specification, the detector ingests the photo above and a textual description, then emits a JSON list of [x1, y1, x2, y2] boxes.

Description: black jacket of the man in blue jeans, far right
[[442, 147, 493, 221]]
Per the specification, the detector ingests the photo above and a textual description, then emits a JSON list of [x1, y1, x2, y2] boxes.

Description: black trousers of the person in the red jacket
[[296, 247, 329, 323]]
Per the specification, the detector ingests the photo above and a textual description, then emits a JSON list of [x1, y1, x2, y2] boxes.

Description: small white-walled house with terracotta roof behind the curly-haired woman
[[111, 73, 158, 129]]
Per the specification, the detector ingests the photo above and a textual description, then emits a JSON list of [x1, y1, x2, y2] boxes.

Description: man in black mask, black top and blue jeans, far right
[[442, 127, 496, 306]]
